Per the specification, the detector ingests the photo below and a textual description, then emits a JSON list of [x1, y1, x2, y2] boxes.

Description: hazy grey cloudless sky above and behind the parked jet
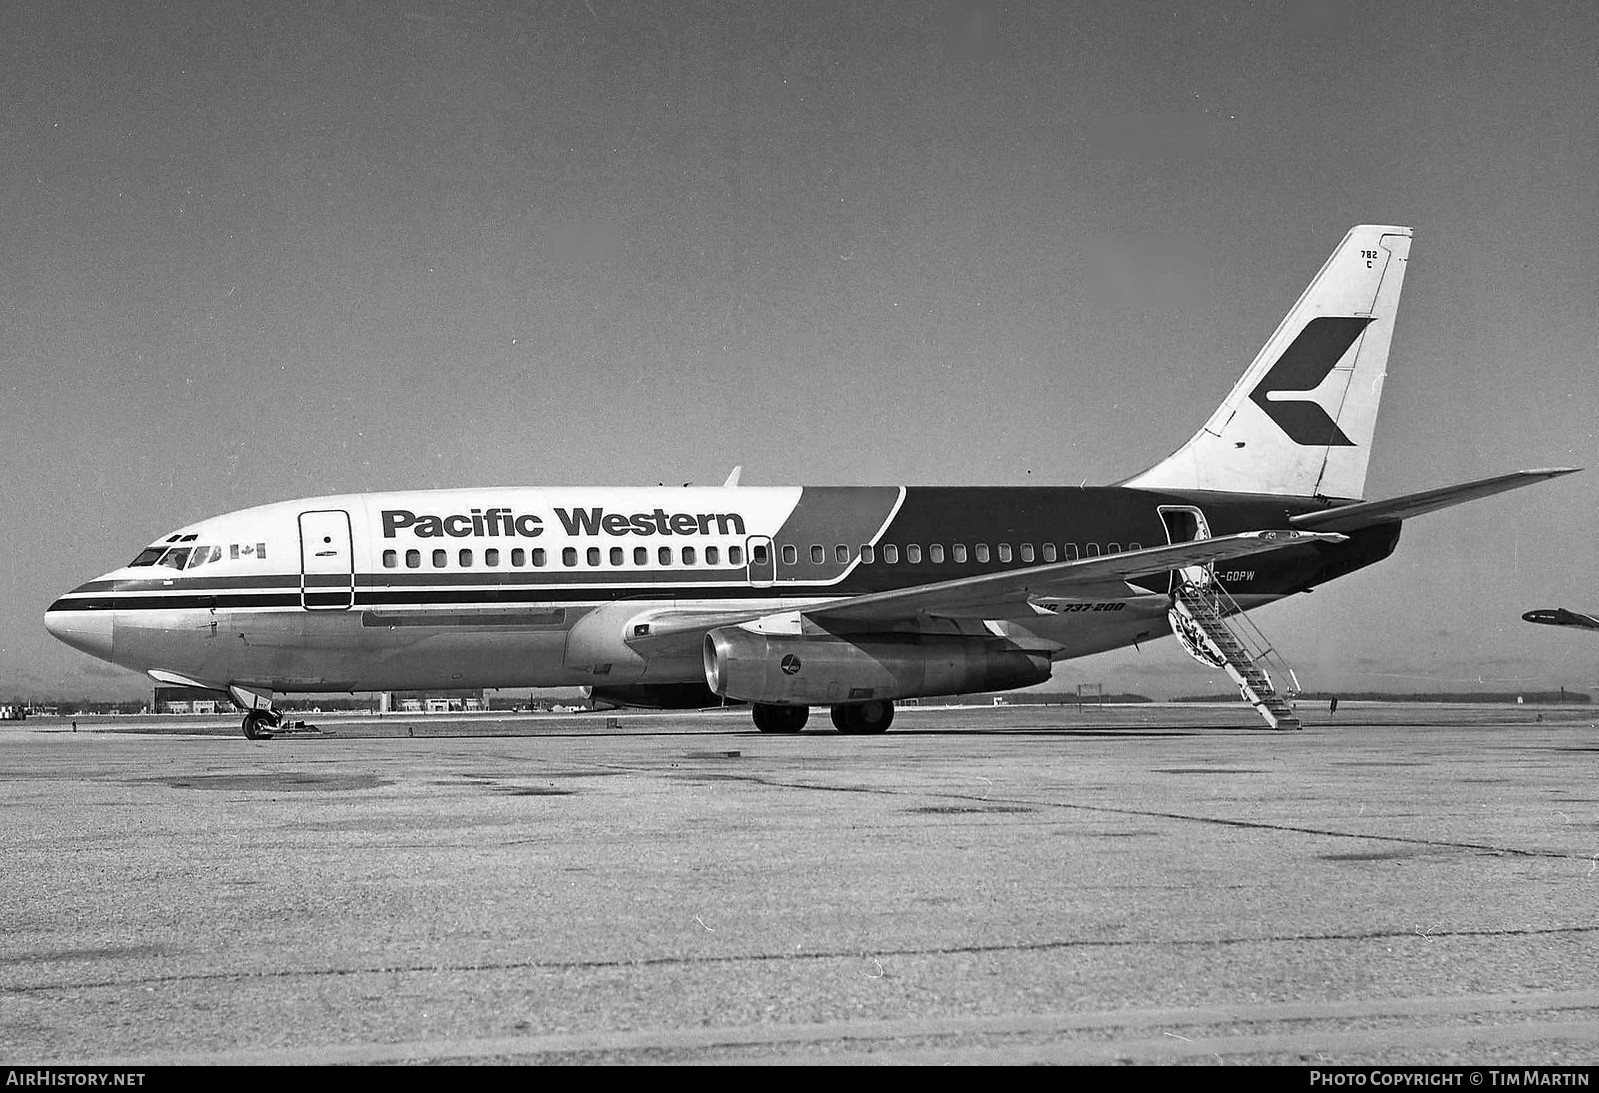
[[0, 0, 1599, 697]]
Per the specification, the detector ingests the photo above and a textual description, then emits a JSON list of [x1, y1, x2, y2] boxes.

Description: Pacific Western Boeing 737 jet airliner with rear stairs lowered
[[45, 225, 1577, 740]]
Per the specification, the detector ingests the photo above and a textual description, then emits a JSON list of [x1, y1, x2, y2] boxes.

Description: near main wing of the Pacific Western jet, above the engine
[[625, 531, 1346, 657]]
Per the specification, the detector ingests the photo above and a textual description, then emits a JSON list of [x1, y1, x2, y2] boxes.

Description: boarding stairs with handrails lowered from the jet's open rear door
[[1172, 574, 1300, 730]]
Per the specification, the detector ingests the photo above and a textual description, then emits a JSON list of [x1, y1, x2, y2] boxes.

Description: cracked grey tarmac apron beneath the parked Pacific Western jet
[[0, 702, 1599, 1069]]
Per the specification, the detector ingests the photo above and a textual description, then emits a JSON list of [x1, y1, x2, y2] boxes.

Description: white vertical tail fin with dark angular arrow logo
[[1121, 224, 1410, 499]]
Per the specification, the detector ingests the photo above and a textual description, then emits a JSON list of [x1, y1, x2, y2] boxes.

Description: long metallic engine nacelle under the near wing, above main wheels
[[705, 626, 1049, 706]]
